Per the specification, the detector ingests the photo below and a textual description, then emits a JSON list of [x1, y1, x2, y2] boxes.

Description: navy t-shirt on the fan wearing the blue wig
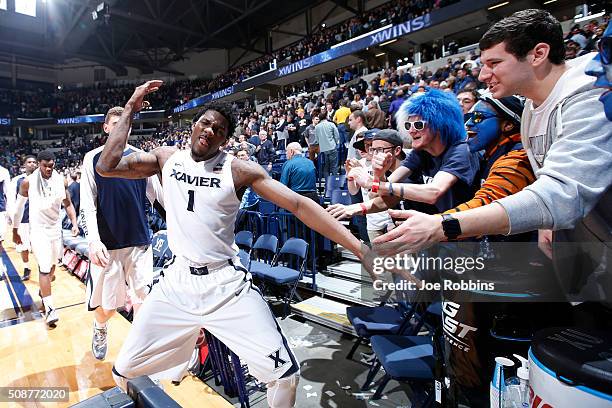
[[402, 141, 480, 212]]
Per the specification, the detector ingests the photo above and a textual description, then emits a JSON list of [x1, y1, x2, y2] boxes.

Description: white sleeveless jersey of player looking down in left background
[[28, 169, 66, 232]]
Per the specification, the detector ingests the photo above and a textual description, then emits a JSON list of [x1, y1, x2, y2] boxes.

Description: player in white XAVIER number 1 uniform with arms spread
[[96, 81, 365, 407]]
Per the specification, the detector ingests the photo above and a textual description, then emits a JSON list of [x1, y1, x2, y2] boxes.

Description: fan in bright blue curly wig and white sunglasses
[[342, 89, 479, 215]]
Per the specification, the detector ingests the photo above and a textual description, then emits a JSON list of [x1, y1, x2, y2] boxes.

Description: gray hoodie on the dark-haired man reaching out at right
[[497, 54, 612, 301]]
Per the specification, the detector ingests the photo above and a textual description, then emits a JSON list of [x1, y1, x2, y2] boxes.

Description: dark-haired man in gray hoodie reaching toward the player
[[374, 10, 612, 300]]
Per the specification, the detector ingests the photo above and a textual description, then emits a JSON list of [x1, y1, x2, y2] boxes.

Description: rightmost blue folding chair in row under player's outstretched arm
[[260, 238, 308, 319]]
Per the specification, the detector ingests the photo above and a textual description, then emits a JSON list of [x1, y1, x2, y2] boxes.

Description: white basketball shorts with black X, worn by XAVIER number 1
[[113, 257, 299, 385]]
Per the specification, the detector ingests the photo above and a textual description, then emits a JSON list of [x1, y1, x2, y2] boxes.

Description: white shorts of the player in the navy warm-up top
[[87, 245, 153, 310]]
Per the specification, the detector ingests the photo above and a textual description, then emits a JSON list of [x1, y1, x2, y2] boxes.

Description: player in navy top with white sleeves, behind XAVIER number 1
[[81, 106, 161, 360]]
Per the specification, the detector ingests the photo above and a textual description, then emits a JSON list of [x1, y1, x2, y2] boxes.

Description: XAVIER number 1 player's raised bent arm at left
[[96, 80, 165, 179]]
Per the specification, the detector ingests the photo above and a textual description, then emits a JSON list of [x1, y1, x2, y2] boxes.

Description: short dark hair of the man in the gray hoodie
[[478, 9, 565, 65]]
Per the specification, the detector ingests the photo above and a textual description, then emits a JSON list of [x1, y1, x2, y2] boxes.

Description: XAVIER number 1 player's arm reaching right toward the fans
[[232, 160, 365, 260]]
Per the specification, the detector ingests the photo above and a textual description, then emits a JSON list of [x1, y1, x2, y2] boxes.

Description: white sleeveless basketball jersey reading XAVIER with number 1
[[162, 150, 240, 264]]
